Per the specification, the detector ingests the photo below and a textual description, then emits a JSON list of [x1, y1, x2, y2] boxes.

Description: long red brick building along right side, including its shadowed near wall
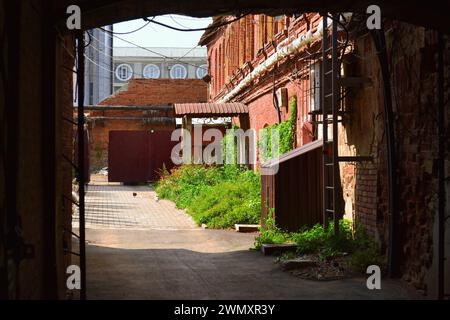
[[200, 13, 450, 293]]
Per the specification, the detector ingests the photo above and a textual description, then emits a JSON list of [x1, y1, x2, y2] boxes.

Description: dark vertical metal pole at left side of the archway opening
[[76, 31, 86, 300]]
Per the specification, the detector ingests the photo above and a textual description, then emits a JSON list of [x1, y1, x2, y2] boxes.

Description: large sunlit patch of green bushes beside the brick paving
[[156, 165, 261, 228]]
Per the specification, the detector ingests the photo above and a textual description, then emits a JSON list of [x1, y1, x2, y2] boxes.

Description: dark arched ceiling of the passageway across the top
[[55, 0, 450, 33]]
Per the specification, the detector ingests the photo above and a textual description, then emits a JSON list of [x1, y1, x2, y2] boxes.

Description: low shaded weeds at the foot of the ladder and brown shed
[[255, 211, 385, 272]]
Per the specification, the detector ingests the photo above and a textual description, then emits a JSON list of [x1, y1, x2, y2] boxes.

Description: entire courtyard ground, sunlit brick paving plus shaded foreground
[[74, 176, 417, 299]]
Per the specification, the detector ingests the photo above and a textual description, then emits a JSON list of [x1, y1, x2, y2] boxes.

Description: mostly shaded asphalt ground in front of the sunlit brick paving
[[83, 230, 416, 299]]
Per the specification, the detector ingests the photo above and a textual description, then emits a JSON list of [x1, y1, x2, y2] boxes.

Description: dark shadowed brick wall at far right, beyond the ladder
[[346, 22, 449, 292]]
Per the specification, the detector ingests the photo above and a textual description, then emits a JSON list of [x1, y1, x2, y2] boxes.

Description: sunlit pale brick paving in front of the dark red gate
[[73, 179, 198, 230]]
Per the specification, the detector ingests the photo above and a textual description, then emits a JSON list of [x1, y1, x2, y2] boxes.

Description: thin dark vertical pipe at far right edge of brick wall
[[437, 32, 446, 300]]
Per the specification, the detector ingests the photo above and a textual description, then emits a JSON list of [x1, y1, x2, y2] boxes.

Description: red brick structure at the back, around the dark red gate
[[86, 79, 206, 171]]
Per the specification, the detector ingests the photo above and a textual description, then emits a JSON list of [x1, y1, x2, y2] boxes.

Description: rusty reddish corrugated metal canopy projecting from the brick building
[[174, 102, 248, 117]]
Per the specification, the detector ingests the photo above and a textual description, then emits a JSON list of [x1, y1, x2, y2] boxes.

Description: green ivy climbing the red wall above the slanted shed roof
[[258, 96, 297, 162]]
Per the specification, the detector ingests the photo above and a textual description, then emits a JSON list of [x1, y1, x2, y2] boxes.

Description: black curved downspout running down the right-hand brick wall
[[371, 28, 398, 277]]
